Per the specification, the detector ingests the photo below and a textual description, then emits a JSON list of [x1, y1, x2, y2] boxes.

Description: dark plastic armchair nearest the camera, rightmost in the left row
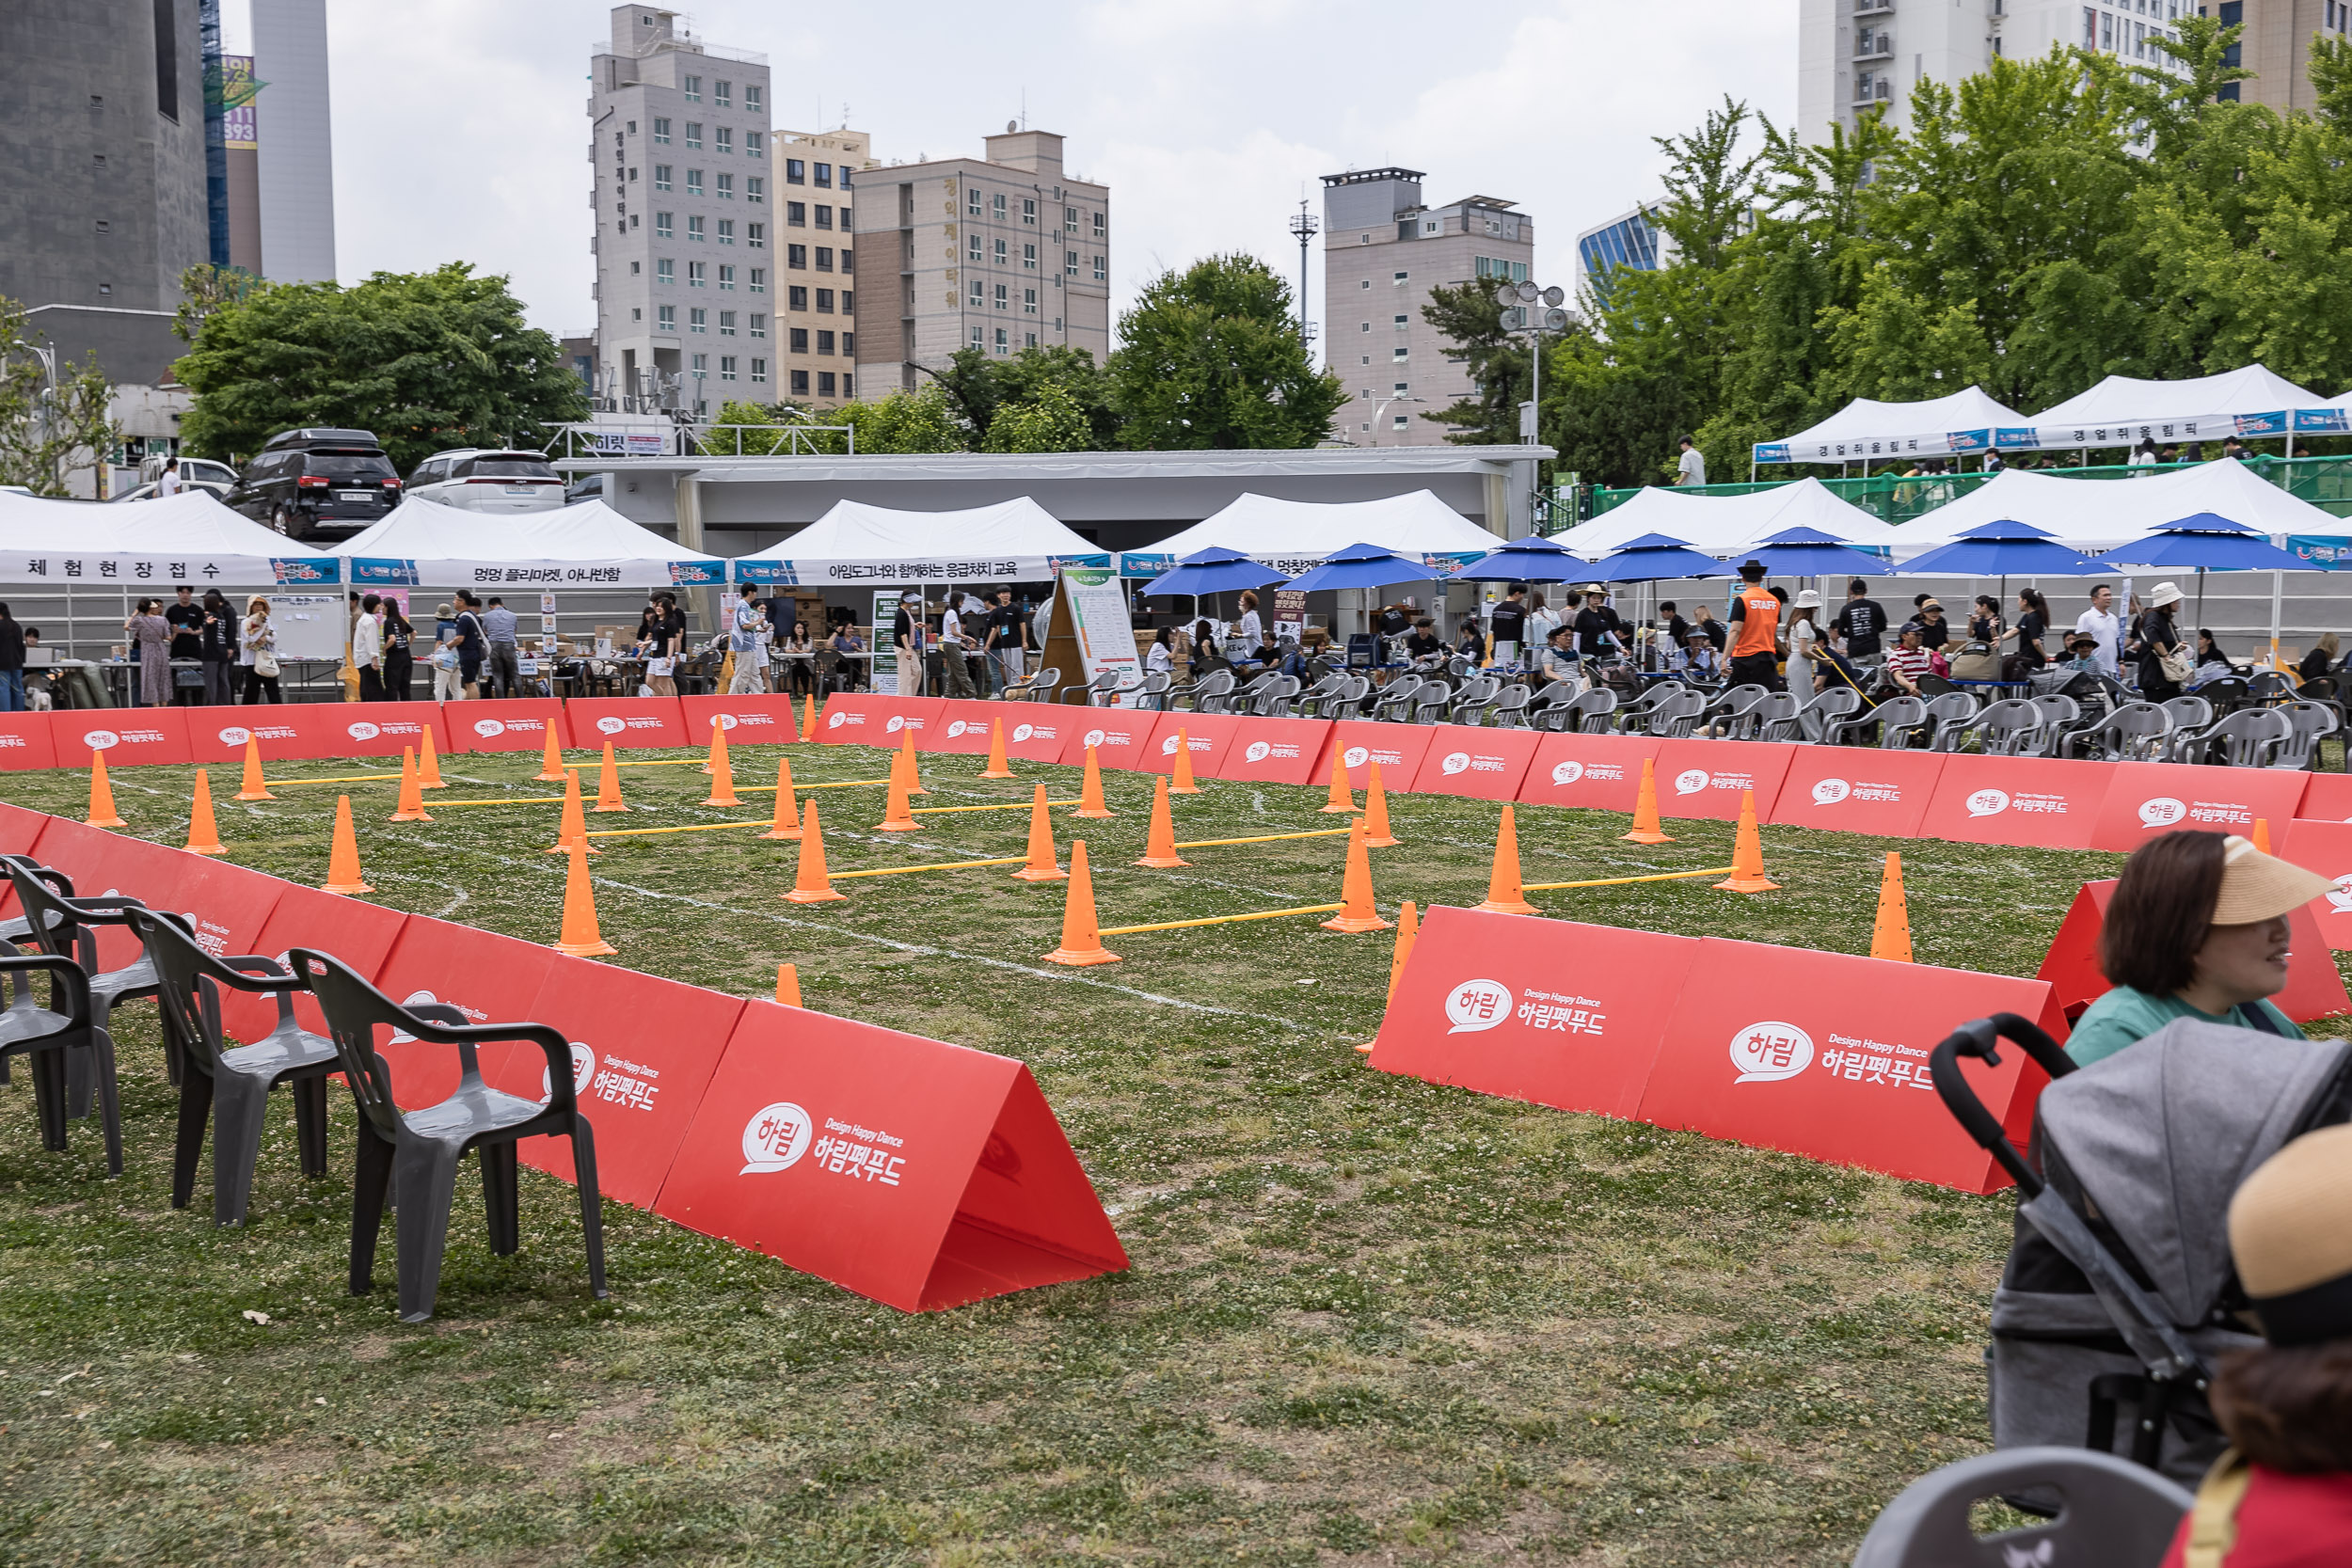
[[287, 947, 607, 1323]]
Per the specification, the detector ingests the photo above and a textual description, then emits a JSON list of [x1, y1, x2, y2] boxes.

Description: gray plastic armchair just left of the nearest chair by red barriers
[[132, 910, 342, 1225]]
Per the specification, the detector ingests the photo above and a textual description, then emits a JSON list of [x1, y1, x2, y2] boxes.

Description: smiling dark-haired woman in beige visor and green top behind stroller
[[2065, 832, 2336, 1068]]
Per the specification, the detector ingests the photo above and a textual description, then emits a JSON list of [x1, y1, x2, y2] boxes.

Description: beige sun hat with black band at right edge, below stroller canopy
[[2230, 1126, 2352, 1345]]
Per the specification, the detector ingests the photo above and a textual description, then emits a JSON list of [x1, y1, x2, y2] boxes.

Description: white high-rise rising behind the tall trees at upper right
[[1797, 0, 2201, 141]]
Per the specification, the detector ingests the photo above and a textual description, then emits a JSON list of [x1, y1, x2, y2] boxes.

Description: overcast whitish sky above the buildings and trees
[[224, 0, 1797, 352]]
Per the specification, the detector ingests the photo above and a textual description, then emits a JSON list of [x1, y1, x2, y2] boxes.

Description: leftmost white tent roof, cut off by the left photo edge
[[0, 489, 342, 593]]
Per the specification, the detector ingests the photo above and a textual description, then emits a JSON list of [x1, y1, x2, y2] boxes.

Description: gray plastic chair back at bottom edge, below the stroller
[[1853, 1449, 2195, 1568]]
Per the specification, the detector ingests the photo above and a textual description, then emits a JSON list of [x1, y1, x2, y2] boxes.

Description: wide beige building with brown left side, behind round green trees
[[856, 129, 1110, 395]]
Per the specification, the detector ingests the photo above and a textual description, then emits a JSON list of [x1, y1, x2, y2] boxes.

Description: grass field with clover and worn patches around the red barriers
[[0, 745, 2296, 1568]]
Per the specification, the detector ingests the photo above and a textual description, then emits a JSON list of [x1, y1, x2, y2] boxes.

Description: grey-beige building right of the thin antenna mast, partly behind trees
[[1322, 169, 1543, 447]]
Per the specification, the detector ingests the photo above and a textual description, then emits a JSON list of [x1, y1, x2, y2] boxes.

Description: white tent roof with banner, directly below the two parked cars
[[334, 496, 727, 588]]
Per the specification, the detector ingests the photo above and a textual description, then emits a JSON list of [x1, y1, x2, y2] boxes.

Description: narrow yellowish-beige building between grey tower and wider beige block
[[770, 129, 897, 409]]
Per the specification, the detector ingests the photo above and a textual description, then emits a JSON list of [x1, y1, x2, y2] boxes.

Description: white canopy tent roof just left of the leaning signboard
[[734, 496, 1110, 588]]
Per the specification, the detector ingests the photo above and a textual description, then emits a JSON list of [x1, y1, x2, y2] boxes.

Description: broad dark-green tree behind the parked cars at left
[[174, 261, 588, 470]]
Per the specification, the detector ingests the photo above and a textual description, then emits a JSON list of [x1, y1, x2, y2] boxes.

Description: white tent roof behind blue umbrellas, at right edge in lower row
[[1896, 458, 2352, 560]]
